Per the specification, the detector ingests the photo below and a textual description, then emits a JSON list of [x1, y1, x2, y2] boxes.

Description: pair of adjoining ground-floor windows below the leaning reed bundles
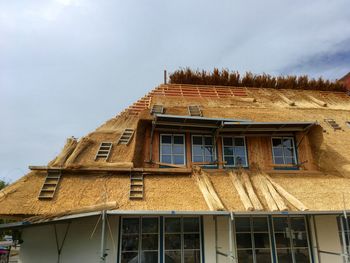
[[235, 216, 310, 263]]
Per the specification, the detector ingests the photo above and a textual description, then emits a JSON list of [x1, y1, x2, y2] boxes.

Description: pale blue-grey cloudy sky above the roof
[[0, 0, 350, 182]]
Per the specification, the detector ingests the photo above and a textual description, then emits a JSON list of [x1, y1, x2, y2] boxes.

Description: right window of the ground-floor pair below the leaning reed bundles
[[272, 217, 310, 263]]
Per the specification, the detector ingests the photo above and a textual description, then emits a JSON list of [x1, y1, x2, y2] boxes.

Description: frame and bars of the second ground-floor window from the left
[[163, 215, 204, 263]]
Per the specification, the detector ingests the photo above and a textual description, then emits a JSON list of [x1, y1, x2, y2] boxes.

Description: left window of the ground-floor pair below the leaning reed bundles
[[235, 217, 272, 263]]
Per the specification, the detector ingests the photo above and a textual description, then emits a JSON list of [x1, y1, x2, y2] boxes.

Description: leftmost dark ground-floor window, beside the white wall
[[120, 217, 159, 263]]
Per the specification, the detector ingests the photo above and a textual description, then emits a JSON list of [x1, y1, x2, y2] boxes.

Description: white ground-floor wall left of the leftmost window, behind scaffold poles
[[20, 216, 119, 263]]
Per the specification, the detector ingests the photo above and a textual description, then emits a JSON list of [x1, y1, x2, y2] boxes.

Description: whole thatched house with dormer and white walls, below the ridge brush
[[0, 81, 350, 263]]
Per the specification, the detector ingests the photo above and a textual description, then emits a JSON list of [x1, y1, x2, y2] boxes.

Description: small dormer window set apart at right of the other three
[[272, 137, 296, 164]]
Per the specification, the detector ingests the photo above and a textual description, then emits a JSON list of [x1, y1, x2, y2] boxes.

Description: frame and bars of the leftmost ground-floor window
[[119, 216, 162, 263]]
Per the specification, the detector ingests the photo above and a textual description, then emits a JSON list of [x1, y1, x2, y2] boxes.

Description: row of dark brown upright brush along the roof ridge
[[169, 68, 346, 92]]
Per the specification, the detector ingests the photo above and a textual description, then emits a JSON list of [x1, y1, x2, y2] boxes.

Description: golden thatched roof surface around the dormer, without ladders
[[0, 85, 350, 219]]
